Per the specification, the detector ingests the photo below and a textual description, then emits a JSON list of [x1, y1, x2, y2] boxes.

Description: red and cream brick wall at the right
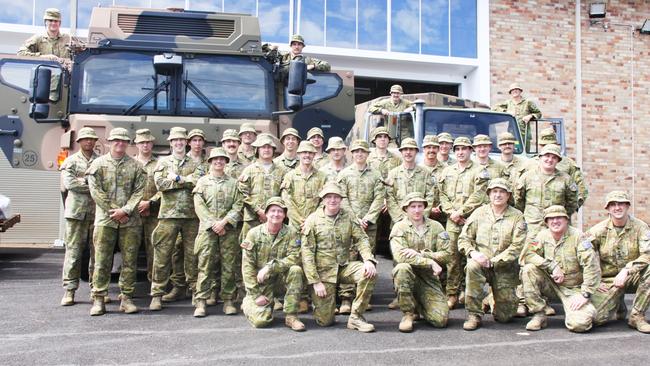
[[490, 0, 650, 228]]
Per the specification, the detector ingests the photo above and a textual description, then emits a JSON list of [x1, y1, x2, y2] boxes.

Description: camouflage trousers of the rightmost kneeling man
[[591, 266, 650, 324]]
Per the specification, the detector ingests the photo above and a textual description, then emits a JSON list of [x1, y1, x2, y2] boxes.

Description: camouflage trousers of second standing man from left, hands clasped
[[93, 226, 142, 297]]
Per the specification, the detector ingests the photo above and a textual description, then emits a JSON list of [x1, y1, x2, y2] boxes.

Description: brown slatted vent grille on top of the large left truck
[[117, 14, 235, 38]]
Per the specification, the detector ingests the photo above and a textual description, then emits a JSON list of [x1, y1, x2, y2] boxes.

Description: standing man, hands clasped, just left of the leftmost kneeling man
[[193, 148, 242, 317]]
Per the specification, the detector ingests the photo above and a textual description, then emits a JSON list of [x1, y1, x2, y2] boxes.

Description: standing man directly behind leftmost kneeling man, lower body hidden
[[238, 131, 286, 241]]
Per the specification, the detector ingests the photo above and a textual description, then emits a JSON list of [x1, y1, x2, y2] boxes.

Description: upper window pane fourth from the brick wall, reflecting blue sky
[[358, 0, 387, 51]]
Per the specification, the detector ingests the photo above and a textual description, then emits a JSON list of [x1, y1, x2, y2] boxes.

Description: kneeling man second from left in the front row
[[301, 183, 377, 332]]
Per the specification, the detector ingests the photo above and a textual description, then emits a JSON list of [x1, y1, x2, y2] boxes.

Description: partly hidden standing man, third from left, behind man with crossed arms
[[133, 128, 160, 282]]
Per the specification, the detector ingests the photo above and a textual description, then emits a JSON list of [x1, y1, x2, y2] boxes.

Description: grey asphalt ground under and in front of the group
[[0, 248, 650, 365]]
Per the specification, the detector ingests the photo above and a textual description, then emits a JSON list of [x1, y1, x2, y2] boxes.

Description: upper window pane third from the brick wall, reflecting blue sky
[[391, 0, 420, 53]]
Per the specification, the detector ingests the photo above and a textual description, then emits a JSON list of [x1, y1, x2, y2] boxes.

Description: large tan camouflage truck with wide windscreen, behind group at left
[[0, 7, 354, 170]]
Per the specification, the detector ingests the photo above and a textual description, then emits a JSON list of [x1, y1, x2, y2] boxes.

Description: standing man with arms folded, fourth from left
[[149, 127, 203, 311]]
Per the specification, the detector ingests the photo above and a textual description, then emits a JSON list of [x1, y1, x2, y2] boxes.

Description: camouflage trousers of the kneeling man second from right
[[521, 263, 596, 332]]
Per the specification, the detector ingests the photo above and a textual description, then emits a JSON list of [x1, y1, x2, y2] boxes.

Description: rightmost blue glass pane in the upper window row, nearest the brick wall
[[451, 0, 476, 58]]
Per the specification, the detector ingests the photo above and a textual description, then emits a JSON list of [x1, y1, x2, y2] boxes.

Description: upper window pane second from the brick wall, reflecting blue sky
[[422, 0, 446, 56]]
